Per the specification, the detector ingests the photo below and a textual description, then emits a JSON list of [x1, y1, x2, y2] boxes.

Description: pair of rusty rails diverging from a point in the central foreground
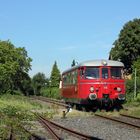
[[35, 114, 100, 140]]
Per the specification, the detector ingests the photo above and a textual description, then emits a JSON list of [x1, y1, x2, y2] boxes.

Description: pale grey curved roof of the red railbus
[[62, 59, 124, 74]]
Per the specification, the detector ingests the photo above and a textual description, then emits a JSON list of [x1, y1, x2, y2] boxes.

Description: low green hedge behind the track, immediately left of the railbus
[[41, 87, 61, 99]]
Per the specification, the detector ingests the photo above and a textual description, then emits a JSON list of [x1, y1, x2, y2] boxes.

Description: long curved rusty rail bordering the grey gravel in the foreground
[[39, 116, 101, 140]]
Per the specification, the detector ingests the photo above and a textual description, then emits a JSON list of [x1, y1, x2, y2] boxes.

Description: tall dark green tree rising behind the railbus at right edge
[[109, 19, 140, 73]]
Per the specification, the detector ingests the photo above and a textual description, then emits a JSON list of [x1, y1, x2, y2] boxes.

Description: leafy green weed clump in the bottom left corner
[[0, 105, 31, 137]]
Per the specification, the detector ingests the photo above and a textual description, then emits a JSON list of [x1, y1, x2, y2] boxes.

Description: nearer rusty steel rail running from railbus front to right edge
[[95, 114, 140, 129]]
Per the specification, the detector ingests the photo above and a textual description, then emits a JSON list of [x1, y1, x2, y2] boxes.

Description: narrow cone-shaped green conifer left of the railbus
[[50, 61, 61, 87]]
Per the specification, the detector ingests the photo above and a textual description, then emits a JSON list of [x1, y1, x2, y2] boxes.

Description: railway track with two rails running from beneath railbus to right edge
[[95, 114, 140, 129]]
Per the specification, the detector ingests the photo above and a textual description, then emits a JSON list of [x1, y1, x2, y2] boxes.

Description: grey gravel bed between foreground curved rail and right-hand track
[[53, 116, 140, 140]]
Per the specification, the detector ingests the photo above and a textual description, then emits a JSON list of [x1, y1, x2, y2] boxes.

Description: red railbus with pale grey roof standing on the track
[[61, 60, 125, 110]]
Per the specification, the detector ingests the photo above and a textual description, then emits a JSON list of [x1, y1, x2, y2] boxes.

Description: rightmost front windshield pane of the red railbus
[[110, 68, 123, 79]]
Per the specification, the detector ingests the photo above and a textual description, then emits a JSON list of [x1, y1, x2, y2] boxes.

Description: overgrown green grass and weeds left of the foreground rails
[[0, 94, 54, 140]]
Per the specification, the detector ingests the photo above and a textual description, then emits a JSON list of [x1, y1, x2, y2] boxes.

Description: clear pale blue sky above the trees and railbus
[[0, 0, 140, 77]]
